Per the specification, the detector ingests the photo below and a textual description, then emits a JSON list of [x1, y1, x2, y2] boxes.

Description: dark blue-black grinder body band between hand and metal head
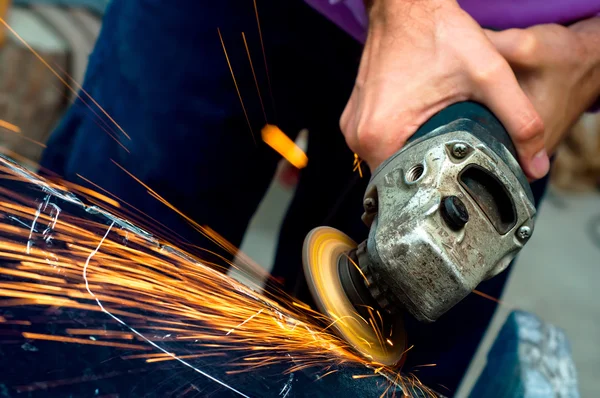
[[407, 101, 518, 159]]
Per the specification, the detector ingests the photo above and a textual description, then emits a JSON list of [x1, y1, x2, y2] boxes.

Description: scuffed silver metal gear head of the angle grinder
[[361, 127, 535, 321]]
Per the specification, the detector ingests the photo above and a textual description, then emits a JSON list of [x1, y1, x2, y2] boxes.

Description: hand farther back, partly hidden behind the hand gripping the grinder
[[487, 18, 600, 153]]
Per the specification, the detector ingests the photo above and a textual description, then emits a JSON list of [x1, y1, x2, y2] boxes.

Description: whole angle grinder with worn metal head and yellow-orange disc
[[302, 102, 536, 366]]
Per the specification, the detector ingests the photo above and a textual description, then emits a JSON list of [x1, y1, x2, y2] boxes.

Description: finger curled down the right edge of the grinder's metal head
[[476, 61, 550, 179]]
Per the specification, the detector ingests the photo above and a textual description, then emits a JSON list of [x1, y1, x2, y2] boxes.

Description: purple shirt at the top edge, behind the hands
[[305, 0, 600, 42]]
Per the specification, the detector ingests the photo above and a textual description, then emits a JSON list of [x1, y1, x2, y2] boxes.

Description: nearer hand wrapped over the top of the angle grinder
[[340, 0, 549, 179]]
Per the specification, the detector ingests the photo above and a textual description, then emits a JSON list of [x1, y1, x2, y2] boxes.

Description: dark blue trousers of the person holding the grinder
[[42, 0, 543, 395]]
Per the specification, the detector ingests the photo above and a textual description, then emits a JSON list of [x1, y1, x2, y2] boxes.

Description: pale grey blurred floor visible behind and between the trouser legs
[[231, 169, 600, 397]]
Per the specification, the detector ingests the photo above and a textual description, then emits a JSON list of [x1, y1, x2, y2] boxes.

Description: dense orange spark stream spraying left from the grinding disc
[[0, 157, 436, 396]]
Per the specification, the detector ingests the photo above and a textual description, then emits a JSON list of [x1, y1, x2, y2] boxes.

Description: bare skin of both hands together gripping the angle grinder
[[340, 0, 600, 180]]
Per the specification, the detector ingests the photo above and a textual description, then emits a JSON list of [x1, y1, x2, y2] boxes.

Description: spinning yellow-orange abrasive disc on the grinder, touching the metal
[[302, 227, 406, 366]]
